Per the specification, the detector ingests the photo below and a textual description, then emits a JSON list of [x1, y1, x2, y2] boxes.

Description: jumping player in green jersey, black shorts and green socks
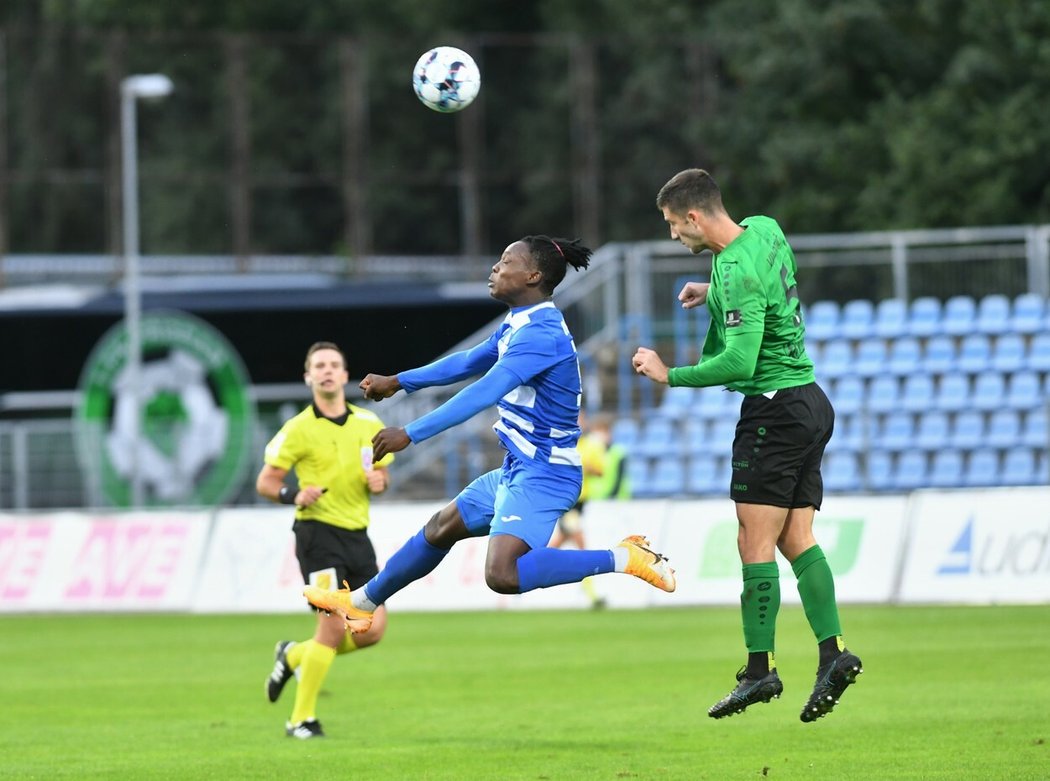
[[632, 168, 862, 721]]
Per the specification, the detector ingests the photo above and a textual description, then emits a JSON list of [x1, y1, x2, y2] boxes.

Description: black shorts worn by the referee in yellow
[[292, 521, 379, 589]]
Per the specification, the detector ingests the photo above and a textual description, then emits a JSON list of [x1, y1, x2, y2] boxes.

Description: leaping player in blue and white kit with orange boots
[[303, 236, 675, 632]]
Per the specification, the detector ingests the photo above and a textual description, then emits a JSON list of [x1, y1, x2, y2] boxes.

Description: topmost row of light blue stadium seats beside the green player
[[804, 293, 1050, 340]]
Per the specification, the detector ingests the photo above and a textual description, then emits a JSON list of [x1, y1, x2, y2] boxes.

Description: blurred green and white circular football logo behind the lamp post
[[74, 312, 255, 507]]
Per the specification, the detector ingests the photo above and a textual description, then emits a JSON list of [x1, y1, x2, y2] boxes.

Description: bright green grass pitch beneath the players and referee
[[0, 606, 1050, 781]]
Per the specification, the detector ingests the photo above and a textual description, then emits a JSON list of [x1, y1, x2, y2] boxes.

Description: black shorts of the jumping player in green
[[730, 382, 835, 510]]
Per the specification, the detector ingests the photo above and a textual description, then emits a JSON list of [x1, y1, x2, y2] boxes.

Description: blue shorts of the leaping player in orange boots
[[456, 453, 583, 548]]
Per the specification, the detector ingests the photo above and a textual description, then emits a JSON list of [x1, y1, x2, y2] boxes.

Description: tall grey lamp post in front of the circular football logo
[[121, 73, 173, 507]]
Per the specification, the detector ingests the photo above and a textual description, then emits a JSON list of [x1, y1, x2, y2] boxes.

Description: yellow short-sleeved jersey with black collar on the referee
[[264, 403, 394, 529]]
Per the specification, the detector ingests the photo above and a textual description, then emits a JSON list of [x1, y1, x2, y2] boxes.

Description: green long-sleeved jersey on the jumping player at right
[[668, 216, 814, 396]]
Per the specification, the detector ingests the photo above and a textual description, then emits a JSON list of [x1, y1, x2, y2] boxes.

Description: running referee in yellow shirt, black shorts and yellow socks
[[255, 341, 394, 740]]
